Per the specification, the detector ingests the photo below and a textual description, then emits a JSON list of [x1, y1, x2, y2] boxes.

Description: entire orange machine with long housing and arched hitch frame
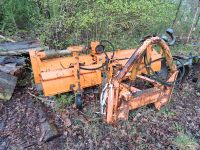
[[30, 29, 183, 123]]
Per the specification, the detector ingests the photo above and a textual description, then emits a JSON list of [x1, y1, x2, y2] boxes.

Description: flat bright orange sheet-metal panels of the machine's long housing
[[29, 49, 161, 96]]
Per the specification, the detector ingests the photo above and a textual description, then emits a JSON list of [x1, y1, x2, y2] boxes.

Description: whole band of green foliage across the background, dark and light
[[0, 0, 176, 49]]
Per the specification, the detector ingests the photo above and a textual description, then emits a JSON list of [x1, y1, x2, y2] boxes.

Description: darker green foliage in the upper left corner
[[0, 0, 39, 31]]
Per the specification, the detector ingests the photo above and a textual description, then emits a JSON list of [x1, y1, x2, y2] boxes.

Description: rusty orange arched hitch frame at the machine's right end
[[101, 37, 178, 123]]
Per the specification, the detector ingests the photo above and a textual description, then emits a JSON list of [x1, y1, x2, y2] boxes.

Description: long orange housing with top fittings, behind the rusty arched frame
[[30, 42, 161, 96]]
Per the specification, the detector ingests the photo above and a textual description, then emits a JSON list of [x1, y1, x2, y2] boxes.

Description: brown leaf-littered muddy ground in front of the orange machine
[[0, 62, 200, 150]]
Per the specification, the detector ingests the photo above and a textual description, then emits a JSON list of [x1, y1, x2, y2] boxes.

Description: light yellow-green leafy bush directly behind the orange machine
[[31, 0, 175, 49]]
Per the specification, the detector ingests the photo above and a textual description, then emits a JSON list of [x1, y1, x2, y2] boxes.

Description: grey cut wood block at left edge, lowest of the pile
[[0, 72, 17, 100]]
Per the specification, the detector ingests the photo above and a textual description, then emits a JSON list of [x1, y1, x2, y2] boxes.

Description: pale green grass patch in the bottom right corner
[[173, 133, 200, 150]]
